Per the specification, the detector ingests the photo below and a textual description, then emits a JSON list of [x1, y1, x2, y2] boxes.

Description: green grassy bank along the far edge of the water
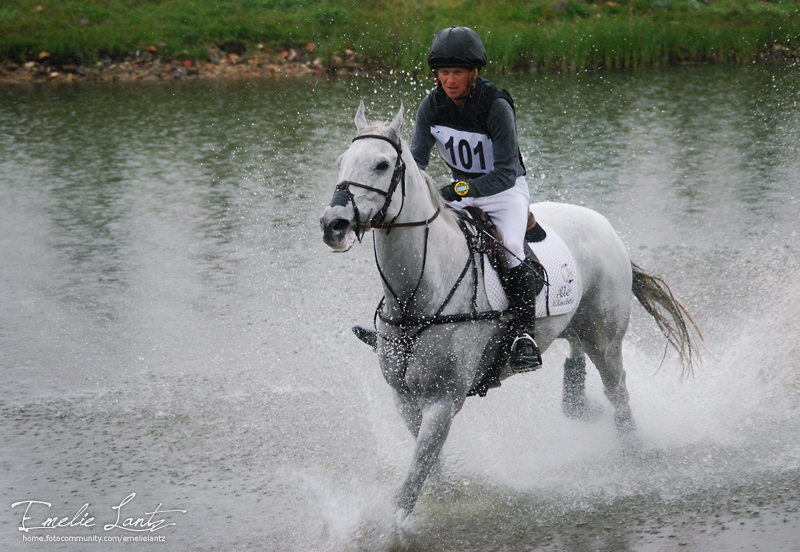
[[0, 0, 800, 72]]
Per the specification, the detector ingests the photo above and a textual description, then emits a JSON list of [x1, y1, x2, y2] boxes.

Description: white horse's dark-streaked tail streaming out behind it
[[631, 262, 705, 378]]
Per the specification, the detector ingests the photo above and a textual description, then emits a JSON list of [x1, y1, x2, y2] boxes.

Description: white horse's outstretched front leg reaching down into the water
[[394, 397, 457, 517]]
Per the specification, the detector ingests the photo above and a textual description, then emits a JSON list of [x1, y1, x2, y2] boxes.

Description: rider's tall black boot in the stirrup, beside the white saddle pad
[[505, 264, 542, 372]]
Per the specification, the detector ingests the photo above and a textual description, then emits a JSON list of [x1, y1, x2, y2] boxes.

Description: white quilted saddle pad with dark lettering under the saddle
[[483, 222, 578, 318]]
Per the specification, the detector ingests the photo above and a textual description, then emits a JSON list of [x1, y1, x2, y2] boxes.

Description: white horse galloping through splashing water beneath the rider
[[320, 102, 702, 515]]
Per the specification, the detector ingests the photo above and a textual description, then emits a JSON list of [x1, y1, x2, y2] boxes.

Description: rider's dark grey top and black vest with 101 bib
[[411, 78, 525, 197]]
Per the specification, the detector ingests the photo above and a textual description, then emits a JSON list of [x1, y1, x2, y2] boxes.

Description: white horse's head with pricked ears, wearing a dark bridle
[[319, 101, 405, 252]]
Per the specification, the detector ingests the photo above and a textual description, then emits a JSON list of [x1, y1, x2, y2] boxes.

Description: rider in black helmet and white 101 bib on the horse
[[353, 27, 542, 371]]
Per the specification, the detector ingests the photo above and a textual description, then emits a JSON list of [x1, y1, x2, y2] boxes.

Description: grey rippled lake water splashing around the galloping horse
[[0, 65, 800, 552]]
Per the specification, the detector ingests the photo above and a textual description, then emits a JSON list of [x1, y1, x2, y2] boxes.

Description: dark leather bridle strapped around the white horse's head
[[331, 134, 440, 243]]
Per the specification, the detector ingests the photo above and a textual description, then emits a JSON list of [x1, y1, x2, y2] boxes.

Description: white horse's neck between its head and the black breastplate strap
[[373, 148, 469, 315]]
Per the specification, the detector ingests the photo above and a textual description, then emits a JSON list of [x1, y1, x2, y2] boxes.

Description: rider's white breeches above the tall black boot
[[450, 176, 531, 268]]
